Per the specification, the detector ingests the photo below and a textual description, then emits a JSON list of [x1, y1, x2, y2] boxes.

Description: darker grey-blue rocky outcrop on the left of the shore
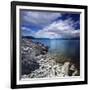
[[21, 38, 48, 75]]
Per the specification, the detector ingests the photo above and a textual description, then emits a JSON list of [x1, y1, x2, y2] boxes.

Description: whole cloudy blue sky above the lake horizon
[[20, 10, 80, 39]]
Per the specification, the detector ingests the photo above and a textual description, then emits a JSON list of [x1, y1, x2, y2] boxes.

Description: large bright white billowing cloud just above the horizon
[[35, 18, 80, 38]]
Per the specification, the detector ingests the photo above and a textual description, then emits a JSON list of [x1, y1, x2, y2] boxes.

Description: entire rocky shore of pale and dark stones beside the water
[[21, 39, 79, 78]]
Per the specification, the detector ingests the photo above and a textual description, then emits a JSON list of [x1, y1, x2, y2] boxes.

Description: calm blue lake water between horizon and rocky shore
[[34, 39, 80, 60]]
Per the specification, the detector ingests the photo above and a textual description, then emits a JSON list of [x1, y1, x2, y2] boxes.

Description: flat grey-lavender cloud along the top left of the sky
[[23, 11, 61, 26]]
